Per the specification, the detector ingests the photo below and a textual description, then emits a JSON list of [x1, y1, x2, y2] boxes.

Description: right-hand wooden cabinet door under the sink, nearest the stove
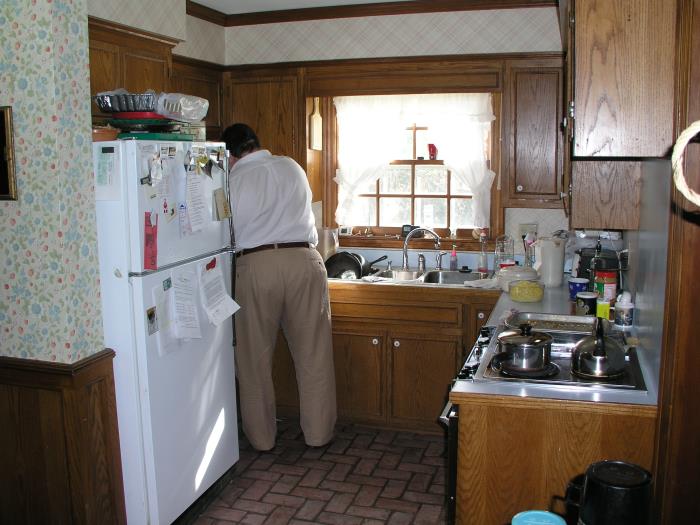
[[389, 334, 461, 431]]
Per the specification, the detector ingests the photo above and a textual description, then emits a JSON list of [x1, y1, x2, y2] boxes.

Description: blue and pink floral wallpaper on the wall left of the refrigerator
[[0, 0, 102, 363]]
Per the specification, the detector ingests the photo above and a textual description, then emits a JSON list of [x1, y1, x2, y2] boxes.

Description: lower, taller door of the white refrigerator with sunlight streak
[[130, 253, 239, 524]]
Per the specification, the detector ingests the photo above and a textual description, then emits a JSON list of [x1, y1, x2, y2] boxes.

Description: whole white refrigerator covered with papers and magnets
[[93, 139, 239, 525]]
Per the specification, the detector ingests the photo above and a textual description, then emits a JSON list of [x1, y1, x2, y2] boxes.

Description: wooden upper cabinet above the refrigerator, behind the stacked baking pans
[[88, 18, 177, 118]]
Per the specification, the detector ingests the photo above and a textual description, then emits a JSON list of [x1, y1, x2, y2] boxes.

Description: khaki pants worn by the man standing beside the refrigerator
[[235, 248, 337, 450]]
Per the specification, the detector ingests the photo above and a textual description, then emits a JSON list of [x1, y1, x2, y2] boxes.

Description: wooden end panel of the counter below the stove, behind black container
[[453, 394, 656, 525]]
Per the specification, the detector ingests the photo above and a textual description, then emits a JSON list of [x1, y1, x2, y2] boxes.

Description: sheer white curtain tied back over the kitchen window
[[333, 93, 495, 228]]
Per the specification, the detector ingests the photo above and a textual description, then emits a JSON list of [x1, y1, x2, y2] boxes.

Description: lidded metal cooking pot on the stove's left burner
[[498, 323, 552, 372]]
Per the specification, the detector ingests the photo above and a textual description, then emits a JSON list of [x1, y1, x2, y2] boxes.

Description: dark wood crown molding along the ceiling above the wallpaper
[[187, 0, 557, 27]]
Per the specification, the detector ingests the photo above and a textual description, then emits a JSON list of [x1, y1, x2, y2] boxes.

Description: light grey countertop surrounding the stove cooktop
[[450, 285, 658, 405]]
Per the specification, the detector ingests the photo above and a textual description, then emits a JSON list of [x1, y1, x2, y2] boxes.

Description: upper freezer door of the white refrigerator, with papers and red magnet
[[122, 140, 230, 273]]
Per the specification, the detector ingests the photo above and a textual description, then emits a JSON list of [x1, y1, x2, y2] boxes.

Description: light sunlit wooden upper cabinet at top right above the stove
[[569, 0, 676, 157]]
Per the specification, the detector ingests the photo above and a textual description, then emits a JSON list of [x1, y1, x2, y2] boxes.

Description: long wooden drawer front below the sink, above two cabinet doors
[[331, 303, 462, 327]]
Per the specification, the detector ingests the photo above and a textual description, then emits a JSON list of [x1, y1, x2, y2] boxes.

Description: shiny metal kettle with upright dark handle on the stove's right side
[[571, 317, 626, 380]]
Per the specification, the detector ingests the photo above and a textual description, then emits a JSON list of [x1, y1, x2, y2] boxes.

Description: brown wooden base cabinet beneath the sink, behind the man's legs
[[272, 282, 499, 433]]
